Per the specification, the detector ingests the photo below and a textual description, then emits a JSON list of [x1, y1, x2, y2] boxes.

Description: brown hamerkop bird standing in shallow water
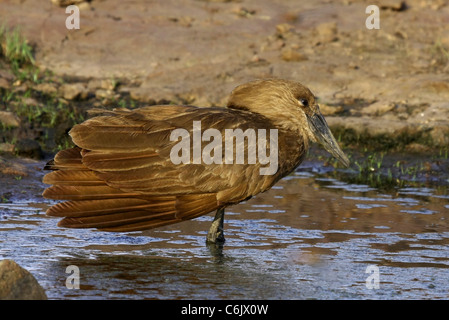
[[43, 79, 349, 243]]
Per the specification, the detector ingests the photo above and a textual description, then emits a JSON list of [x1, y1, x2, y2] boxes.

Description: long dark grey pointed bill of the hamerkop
[[307, 111, 349, 167]]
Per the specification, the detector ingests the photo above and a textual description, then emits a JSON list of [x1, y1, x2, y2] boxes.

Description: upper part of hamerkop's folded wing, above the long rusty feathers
[[70, 106, 271, 200]]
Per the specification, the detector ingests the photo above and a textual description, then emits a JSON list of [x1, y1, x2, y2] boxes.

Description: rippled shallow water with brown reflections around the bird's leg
[[0, 161, 449, 299]]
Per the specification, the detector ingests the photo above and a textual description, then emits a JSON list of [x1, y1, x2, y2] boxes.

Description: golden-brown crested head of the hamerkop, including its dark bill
[[227, 79, 349, 166]]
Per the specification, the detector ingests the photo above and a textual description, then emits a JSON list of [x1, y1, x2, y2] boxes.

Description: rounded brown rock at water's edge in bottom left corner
[[0, 260, 47, 300]]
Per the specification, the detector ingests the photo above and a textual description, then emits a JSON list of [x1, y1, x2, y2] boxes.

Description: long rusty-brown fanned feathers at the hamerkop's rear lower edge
[[43, 147, 217, 232]]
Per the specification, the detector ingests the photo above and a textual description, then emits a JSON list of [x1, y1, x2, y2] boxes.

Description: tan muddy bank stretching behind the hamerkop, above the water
[[0, 0, 449, 158]]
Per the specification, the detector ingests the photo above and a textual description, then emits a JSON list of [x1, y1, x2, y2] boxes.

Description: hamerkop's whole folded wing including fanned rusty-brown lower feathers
[[44, 106, 275, 231]]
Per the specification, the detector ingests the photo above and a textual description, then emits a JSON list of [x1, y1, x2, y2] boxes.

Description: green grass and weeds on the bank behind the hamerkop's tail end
[[0, 25, 139, 153]]
